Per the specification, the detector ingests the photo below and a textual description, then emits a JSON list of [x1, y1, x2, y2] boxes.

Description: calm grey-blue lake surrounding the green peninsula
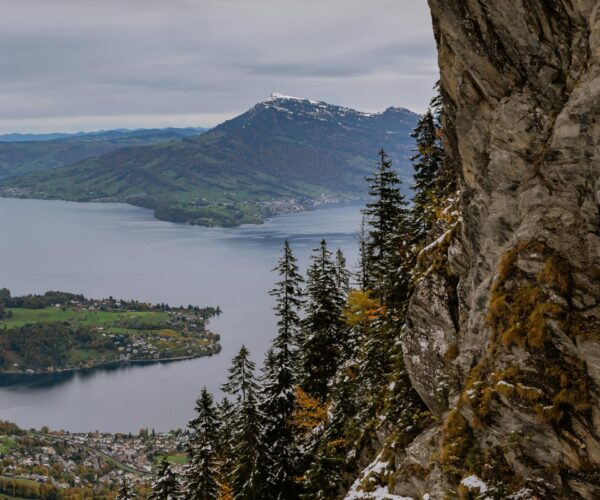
[[0, 199, 361, 432]]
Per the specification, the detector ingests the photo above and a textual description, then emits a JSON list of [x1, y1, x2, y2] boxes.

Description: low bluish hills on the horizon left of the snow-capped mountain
[[0, 127, 208, 179]]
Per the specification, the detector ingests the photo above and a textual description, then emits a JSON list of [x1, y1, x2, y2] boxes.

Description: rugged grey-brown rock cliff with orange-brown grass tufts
[[360, 0, 600, 499]]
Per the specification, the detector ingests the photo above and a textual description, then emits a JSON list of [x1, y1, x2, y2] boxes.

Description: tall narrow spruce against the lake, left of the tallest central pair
[[260, 241, 303, 500]]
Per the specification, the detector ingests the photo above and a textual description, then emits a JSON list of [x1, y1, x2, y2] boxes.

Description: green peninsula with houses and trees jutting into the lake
[[0, 288, 221, 374]]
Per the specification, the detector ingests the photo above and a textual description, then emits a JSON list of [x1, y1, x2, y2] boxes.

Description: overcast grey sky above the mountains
[[0, 0, 437, 133]]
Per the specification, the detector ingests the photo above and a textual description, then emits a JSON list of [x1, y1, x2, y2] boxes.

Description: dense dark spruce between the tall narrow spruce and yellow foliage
[[300, 240, 345, 401]]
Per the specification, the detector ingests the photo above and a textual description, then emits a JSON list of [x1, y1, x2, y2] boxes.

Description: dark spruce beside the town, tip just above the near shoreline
[[183, 387, 219, 500]]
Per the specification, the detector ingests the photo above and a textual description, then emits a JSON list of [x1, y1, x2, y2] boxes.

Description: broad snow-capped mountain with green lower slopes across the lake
[[0, 94, 418, 226]]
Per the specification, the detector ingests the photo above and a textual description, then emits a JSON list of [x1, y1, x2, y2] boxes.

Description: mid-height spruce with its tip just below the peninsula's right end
[[223, 346, 265, 500]]
